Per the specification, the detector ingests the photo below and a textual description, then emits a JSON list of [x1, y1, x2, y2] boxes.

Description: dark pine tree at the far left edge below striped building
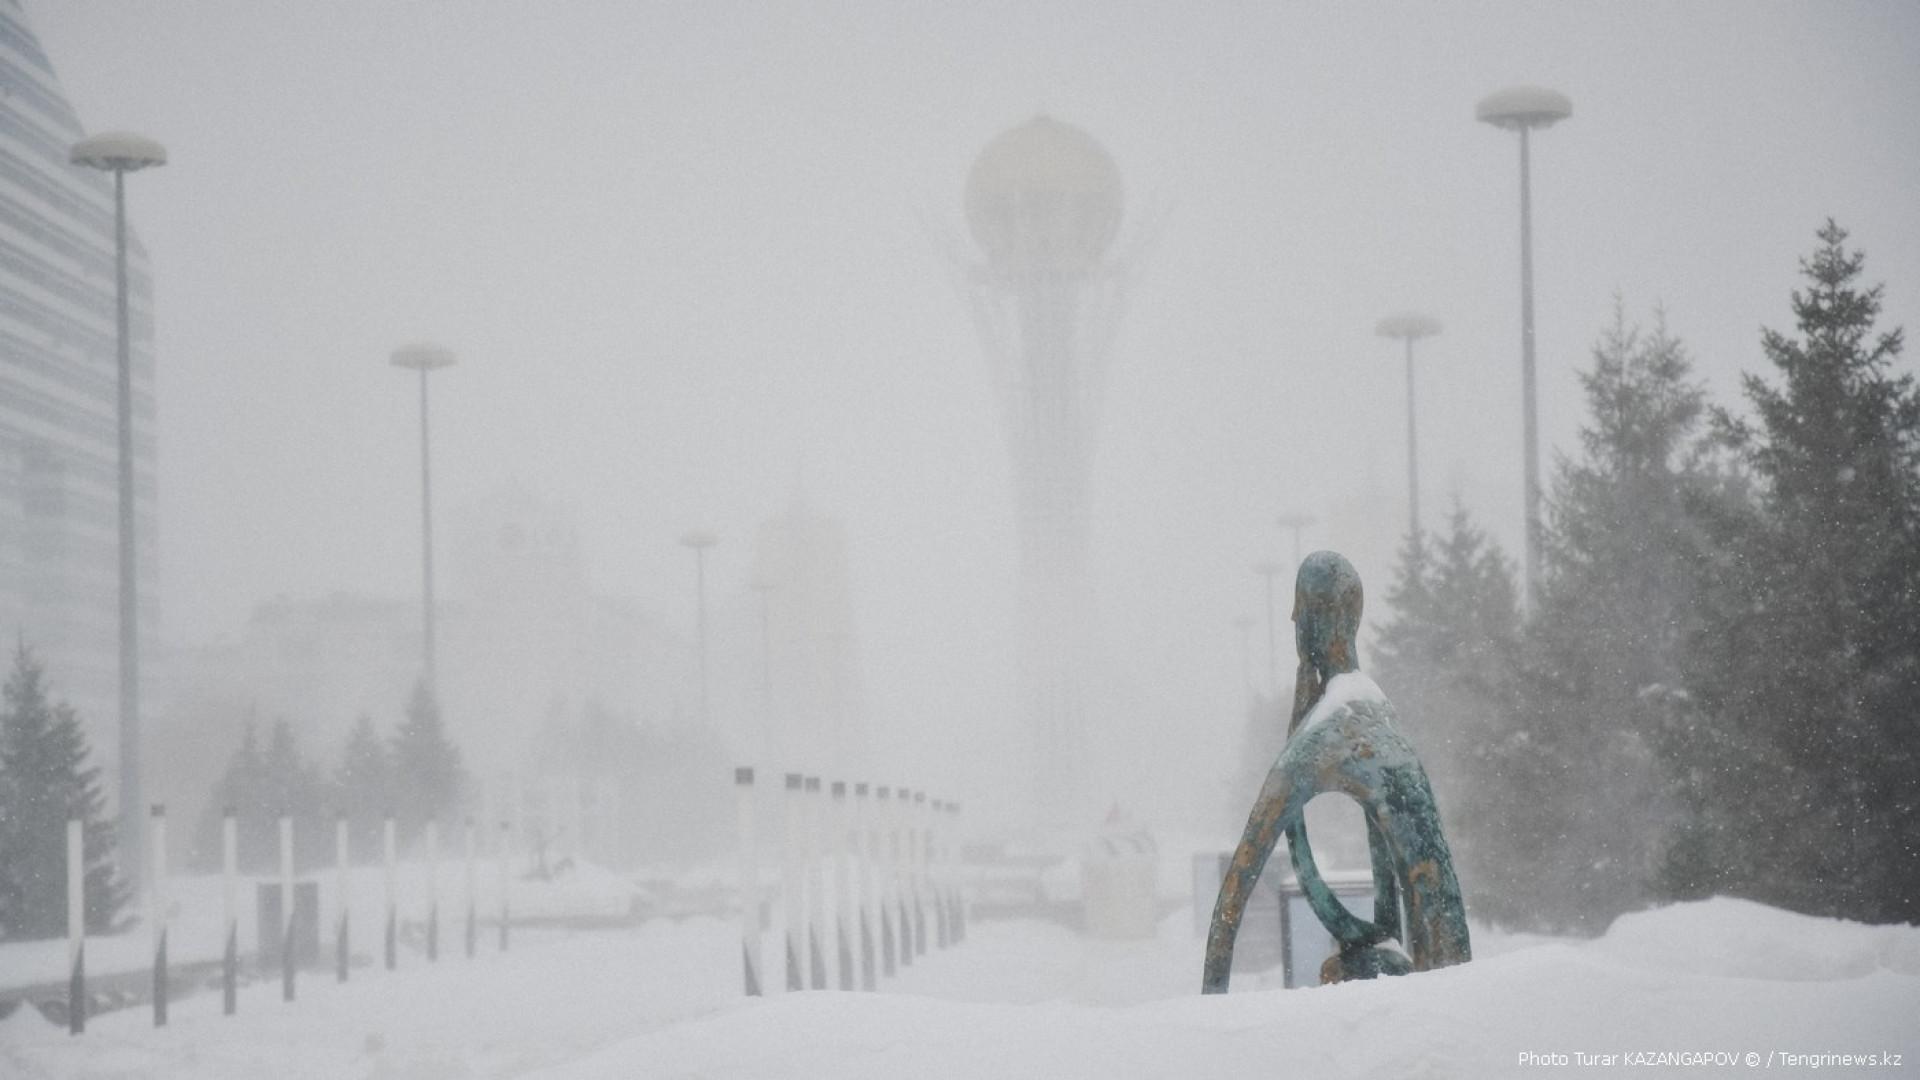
[[0, 644, 127, 940]]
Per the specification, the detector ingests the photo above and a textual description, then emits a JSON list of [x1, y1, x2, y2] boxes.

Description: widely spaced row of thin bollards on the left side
[[67, 803, 511, 1034]]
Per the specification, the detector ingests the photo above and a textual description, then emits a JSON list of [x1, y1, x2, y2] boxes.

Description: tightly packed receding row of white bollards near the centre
[[733, 765, 966, 995]]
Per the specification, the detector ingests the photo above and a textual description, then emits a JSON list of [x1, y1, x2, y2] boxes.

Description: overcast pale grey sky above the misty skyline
[[27, 0, 1920, 814]]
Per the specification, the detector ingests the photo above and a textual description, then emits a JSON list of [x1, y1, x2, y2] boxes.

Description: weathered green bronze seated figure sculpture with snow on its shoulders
[[1200, 552, 1473, 994]]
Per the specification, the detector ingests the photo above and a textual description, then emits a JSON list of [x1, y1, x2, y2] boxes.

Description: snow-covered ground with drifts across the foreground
[[0, 899, 1920, 1080]]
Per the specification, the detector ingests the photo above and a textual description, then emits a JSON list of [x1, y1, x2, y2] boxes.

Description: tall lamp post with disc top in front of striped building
[[67, 131, 167, 884]]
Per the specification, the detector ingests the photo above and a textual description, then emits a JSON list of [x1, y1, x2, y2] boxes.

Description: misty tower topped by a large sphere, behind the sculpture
[[964, 115, 1125, 824]]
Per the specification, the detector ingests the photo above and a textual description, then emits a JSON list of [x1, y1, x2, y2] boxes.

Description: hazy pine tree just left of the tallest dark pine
[[1515, 304, 1715, 932]]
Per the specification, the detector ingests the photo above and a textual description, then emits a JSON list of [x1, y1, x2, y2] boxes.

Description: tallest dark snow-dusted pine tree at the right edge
[[1709, 221, 1920, 922]]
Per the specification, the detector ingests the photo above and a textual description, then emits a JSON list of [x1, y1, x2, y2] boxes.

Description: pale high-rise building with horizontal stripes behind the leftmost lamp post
[[0, 0, 159, 749]]
